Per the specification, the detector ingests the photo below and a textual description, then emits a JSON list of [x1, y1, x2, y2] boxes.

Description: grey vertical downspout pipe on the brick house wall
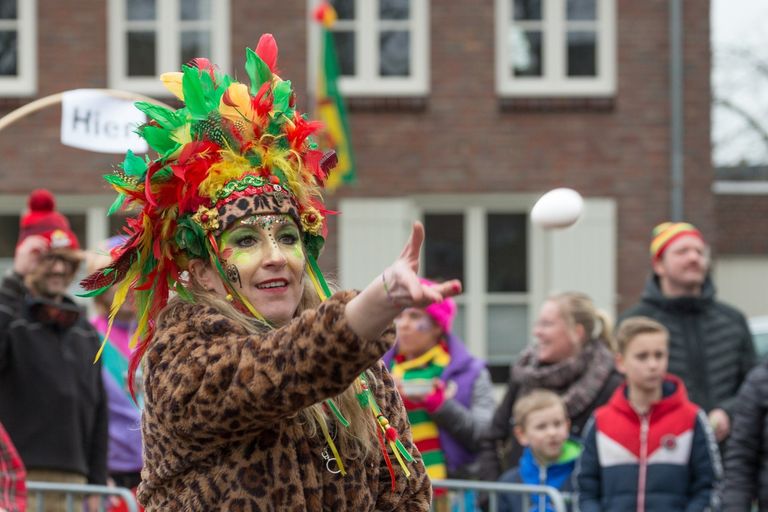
[[669, 0, 685, 221]]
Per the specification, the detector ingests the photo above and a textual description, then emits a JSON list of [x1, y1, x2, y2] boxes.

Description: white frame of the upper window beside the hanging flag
[[307, 0, 430, 97]]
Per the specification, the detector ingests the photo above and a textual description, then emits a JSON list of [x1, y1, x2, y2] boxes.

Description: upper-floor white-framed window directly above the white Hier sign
[[109, 0, 230, 94]]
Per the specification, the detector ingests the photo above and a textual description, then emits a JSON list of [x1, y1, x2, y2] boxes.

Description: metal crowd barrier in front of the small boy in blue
[[432, 480, 570, 512]]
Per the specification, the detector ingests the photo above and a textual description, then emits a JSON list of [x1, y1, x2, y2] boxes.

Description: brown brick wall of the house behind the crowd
[[0, 0, 714, 309]]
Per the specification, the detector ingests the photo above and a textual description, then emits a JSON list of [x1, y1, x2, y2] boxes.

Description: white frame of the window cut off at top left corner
[[0, 0, 37, 96]]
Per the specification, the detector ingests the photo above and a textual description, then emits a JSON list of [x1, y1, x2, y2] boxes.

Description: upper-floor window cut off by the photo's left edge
[[0, 0, 37, 96]]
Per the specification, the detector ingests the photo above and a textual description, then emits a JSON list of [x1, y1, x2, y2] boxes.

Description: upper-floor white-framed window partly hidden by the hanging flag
[[309, 0, 429, 96]]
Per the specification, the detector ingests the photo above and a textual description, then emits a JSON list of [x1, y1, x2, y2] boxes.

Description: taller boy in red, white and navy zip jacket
[[576, 317, 721, 512]]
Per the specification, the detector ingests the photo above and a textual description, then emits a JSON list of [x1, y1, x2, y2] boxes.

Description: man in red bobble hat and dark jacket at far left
[[0, 189, 107, 511]]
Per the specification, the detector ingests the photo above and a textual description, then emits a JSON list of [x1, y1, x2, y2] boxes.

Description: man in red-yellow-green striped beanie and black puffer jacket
[[620, 222, 755, 442]]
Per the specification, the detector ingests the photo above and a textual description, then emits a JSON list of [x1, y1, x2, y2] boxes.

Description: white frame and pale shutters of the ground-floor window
[[337, 193, 618, 364]]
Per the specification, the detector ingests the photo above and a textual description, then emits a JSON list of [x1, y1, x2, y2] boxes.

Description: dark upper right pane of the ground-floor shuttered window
[[487, 213, 528, 293]]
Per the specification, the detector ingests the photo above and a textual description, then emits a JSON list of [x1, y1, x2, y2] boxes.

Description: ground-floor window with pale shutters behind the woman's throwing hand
[[335, 193, 617, 382]]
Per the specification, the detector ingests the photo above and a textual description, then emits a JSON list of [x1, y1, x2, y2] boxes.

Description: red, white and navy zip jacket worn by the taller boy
[[576, 375, 721, 512]]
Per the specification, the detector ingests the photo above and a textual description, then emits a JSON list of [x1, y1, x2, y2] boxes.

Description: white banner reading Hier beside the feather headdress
[[61, 89, 149, 153]]
